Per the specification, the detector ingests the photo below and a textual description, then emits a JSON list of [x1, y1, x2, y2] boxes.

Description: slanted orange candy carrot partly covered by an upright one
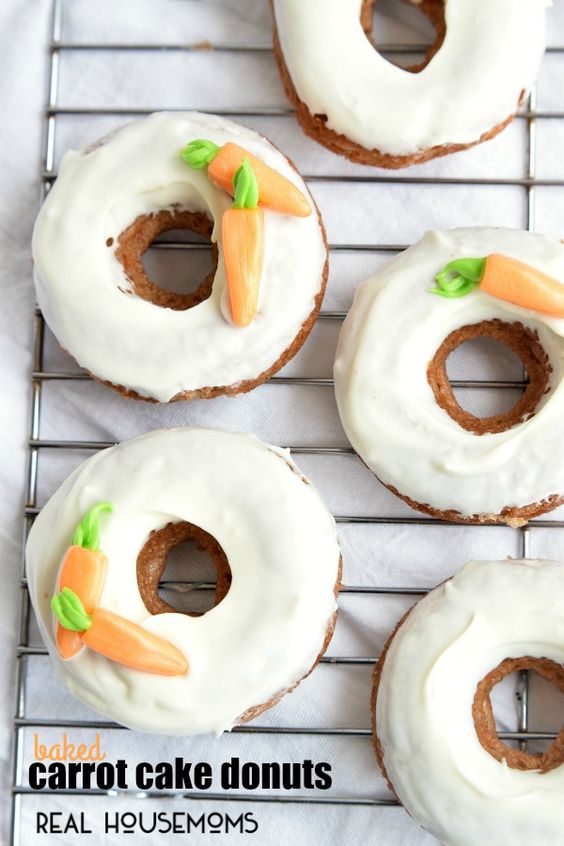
[[179, 139, 311, 217]]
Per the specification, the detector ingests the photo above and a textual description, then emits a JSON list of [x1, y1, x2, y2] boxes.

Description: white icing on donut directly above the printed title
[[27, 428, 340, 735]]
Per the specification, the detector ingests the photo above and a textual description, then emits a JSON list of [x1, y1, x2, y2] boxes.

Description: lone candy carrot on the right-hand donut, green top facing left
[[430, 253, 564, 317]]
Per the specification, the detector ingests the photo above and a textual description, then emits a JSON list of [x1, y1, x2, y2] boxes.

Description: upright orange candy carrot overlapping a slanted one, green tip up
[[221, 159, 264, 326]]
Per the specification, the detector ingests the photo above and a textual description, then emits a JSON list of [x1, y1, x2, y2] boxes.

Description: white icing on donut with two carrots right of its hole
[[33, 112, 326, 402]]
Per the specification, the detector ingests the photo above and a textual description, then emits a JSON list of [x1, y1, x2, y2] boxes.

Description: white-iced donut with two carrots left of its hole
[[26, 428, 341, 735]]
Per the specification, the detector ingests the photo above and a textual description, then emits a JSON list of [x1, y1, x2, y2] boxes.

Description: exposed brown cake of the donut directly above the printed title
[[137, 522, 343, 725]]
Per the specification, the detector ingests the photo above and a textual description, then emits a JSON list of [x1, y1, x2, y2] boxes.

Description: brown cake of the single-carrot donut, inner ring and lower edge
[[369, 320, 564, 528]]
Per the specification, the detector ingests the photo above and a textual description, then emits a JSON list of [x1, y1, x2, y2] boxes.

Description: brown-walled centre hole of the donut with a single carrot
[[427, 320, 552, 435]]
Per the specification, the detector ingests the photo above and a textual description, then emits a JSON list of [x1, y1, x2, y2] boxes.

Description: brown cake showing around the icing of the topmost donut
[[270, 0, 525, 170]]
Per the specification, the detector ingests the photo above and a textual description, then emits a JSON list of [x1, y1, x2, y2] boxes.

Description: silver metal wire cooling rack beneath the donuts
[[10, 0, 564, 846]]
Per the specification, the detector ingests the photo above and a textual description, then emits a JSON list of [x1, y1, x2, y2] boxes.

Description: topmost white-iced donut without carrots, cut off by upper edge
[[271, 0, 546, 168]]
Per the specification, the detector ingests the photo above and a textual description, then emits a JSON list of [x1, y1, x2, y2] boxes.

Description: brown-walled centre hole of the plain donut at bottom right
[[472, 657, 564, 772]]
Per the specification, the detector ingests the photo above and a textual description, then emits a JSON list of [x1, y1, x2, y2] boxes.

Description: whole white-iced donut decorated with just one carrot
[[334, 228, 564, 526]]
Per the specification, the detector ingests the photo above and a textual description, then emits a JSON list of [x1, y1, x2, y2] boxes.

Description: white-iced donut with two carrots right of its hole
[[33, 112, 327, 402]]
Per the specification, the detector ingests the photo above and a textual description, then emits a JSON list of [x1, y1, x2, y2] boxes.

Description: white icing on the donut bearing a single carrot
[[335, 228, 564, 515]]
